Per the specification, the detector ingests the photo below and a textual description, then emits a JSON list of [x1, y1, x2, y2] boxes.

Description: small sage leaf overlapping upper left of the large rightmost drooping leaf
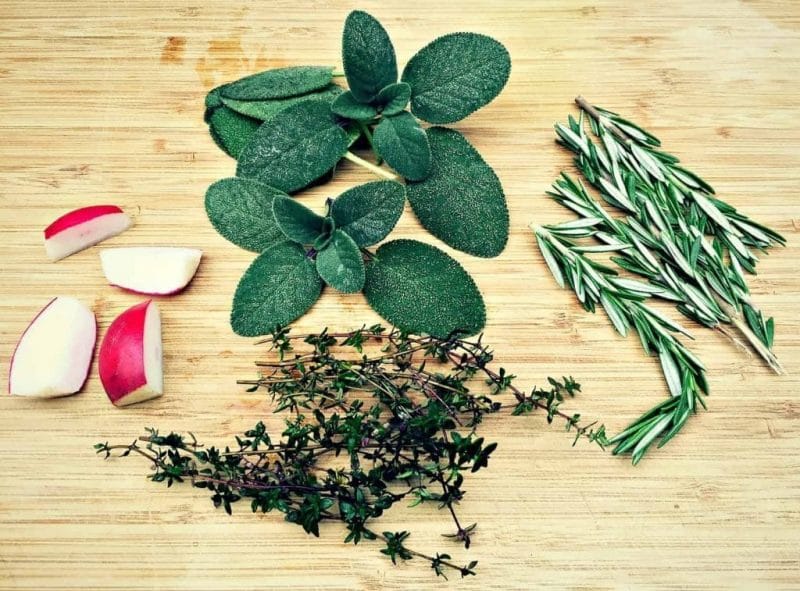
[[372, 111, 431, 181]]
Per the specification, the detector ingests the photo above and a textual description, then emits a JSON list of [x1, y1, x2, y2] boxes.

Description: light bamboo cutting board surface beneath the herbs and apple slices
[[0, 0, 800, 590]]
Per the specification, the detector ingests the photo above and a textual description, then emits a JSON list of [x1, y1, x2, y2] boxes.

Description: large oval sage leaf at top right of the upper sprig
[[402, 33, 511, 123]]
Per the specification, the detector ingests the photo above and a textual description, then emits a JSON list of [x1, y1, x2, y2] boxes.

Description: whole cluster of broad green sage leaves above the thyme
[[205, 11, 511, 337]]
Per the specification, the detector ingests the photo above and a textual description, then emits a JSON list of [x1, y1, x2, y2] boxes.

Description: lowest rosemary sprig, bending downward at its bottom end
[[532, 218, 708, 464]]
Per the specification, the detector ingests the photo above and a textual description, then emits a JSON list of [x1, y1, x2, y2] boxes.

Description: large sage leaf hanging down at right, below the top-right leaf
[[406, 127, 508, 257]]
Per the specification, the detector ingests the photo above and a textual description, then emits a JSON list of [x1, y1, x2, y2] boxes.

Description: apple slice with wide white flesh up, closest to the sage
[[100, 246, 203, 295]]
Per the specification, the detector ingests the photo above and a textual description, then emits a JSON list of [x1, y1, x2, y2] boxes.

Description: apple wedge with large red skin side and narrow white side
[[98, 300, 164, 406]]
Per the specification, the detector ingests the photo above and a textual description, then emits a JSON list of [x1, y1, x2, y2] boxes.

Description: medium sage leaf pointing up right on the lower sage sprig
[[331, 181, 406, 247]]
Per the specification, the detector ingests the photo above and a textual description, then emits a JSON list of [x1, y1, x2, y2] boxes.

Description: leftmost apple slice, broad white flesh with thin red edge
[[8, 297, 97, 398]]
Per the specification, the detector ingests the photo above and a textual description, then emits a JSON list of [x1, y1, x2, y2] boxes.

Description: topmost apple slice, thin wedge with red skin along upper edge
[[44, 205, 132, 261]]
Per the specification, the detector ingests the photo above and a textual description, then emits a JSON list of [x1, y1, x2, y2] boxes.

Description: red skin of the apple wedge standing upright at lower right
[[98, 300, 152, 404]]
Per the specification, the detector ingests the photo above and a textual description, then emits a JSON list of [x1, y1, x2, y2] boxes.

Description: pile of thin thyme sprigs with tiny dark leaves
[[95, 325, 606, 576]]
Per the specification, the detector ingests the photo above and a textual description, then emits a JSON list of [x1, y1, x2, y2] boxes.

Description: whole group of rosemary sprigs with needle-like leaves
[[533, 97, 784, 463]]
